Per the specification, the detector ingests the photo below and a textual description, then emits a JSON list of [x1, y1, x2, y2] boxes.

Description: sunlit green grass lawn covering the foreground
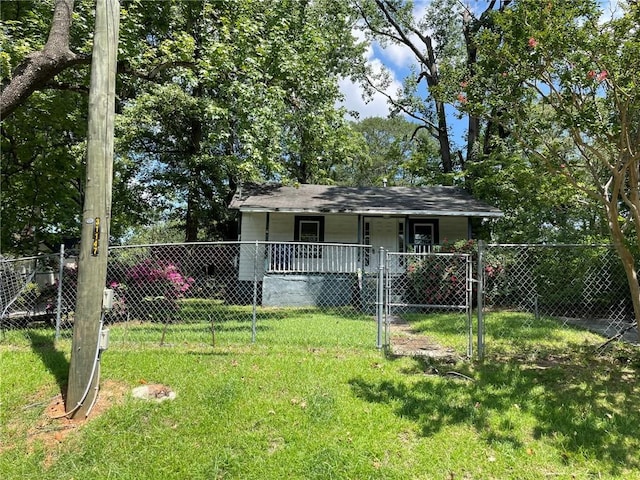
[[0, 311, 640, 480]]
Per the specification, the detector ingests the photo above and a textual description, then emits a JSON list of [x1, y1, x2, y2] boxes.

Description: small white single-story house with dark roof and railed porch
[[230, 184, 502, 303]]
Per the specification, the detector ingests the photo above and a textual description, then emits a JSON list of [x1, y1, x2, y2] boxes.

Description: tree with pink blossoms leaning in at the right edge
[[466, 0, 640, 338]]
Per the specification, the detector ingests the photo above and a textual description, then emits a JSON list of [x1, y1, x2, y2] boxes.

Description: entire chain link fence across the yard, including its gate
[[0, 242, 637, 357]]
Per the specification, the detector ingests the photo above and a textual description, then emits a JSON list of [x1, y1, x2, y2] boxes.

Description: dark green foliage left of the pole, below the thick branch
[[0, 92, 86, 252]]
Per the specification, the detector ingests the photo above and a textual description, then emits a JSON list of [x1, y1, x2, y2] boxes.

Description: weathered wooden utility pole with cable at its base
[[65, 0, 120, 417]]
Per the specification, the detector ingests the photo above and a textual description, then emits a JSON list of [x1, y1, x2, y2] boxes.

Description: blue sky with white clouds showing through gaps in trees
[[340, 0, 623, 124]]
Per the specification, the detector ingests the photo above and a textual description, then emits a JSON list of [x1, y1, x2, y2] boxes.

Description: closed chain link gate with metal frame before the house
[[380, 252, 473, 358]]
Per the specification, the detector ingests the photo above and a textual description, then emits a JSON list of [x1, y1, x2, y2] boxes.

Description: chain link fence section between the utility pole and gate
[[105, 242, 376, 345]]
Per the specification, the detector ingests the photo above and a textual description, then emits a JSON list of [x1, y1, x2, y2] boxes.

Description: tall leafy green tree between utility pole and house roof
[[116, 0, 359, 241]]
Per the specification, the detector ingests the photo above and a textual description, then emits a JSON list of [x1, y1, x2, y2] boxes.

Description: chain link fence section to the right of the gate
[[478, 244, 637, 356]]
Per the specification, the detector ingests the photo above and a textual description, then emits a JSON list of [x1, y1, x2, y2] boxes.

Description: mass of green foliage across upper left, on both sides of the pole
[[0, 0, 362, 252]]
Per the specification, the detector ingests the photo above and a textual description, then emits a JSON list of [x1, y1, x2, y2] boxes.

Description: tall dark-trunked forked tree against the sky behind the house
[[354, 0, 510, 179]]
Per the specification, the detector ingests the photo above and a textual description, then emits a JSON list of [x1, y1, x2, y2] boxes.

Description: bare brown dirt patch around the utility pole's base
[[27, 380, 130, 464]]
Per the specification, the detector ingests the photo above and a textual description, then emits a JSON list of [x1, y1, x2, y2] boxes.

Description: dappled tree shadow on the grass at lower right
[[350, 349, 640, 475]]
